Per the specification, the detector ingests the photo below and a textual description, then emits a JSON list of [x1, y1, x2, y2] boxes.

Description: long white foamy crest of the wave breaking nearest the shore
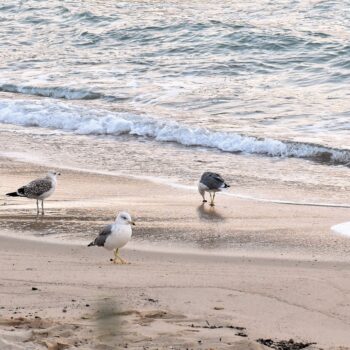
[[0, 99, 350, 164]]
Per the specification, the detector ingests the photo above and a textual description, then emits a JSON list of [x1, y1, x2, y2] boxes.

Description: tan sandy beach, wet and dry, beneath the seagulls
[[0, 158, 350, 350]]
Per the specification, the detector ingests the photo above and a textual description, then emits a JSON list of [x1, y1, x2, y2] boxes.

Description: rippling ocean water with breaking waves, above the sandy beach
[[0, 0, 350, 196]]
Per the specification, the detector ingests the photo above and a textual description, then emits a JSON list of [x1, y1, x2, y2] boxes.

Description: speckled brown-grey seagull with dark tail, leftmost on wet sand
[[6, 171, 61, 215]]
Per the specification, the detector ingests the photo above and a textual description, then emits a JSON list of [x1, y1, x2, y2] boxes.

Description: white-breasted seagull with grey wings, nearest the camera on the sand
[[88, 212, 135, 264]]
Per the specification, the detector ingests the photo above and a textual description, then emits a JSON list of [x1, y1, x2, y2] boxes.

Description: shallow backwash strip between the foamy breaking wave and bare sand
[[0, 121, 348, 205]]
